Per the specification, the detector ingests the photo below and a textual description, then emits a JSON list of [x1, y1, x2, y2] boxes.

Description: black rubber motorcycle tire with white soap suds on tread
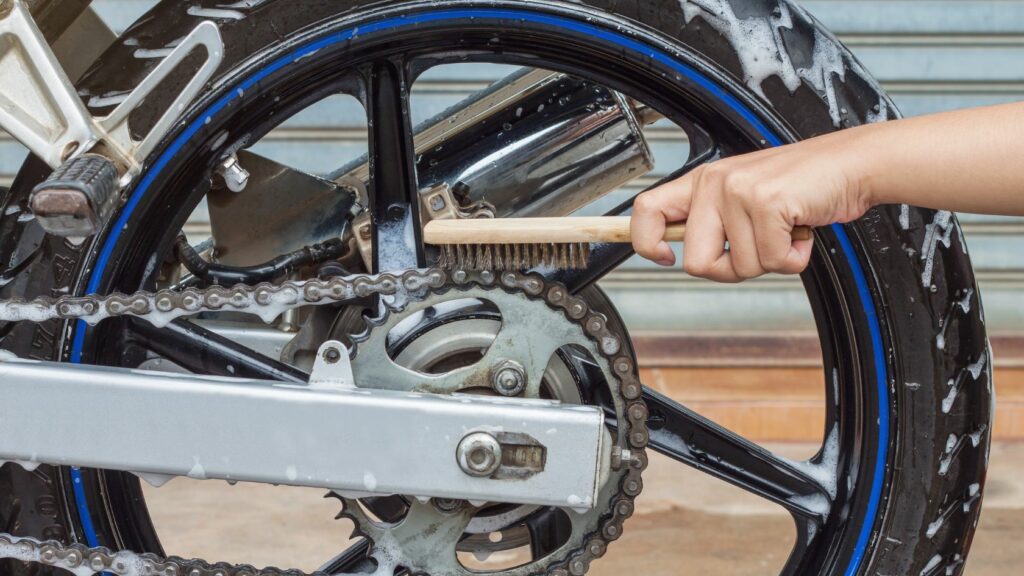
[[0, 0, 992, 576]]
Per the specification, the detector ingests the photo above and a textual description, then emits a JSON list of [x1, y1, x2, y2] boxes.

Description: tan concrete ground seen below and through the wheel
[[138, 443, 1024, 576]]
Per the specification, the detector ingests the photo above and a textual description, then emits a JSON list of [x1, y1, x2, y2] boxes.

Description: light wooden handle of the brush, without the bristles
[[423, 216, 812, 241]]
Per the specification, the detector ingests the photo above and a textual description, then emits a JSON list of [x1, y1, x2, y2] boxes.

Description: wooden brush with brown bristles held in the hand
[[423, 216, 813, 270]]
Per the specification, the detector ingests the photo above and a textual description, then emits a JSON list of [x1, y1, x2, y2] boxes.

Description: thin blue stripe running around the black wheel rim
[[71, 8, 889, 576]]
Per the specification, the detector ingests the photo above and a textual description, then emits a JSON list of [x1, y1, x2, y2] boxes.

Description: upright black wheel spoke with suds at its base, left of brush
[[366, 60, 426, 272]]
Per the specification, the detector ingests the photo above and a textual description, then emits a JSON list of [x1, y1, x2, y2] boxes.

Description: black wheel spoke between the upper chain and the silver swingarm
[[125, 319, 309, 384]]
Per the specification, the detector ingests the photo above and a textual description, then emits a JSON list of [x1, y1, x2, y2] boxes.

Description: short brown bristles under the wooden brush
[[437, 243, 590, 272]]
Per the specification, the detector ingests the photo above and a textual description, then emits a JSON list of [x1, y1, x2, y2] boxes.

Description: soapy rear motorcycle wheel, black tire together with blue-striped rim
[[0, 0, 992, 575]]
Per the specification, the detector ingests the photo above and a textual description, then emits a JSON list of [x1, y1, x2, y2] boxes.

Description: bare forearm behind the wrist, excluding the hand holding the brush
[[835, 102, 1024, 215]]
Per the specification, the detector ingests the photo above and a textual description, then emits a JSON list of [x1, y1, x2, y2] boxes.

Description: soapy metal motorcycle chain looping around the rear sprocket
[[0, 269, 649, 576]]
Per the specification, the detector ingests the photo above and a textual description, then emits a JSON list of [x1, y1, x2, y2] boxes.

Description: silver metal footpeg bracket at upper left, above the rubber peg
[[0, 0, 224, 177]]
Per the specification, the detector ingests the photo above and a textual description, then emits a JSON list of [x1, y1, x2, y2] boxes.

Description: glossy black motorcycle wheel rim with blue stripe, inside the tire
[[64, 5, 891, 574]]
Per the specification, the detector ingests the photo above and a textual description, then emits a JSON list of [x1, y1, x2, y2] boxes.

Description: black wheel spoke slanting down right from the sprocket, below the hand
[[644, 388, 833, 521]]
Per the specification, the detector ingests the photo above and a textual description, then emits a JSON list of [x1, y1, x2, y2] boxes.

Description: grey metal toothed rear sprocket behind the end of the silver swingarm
[[340, 271, 647, 576]]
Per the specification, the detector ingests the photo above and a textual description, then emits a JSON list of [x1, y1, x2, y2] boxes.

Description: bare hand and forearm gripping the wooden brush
[[633, 104, 1024, 282]]
